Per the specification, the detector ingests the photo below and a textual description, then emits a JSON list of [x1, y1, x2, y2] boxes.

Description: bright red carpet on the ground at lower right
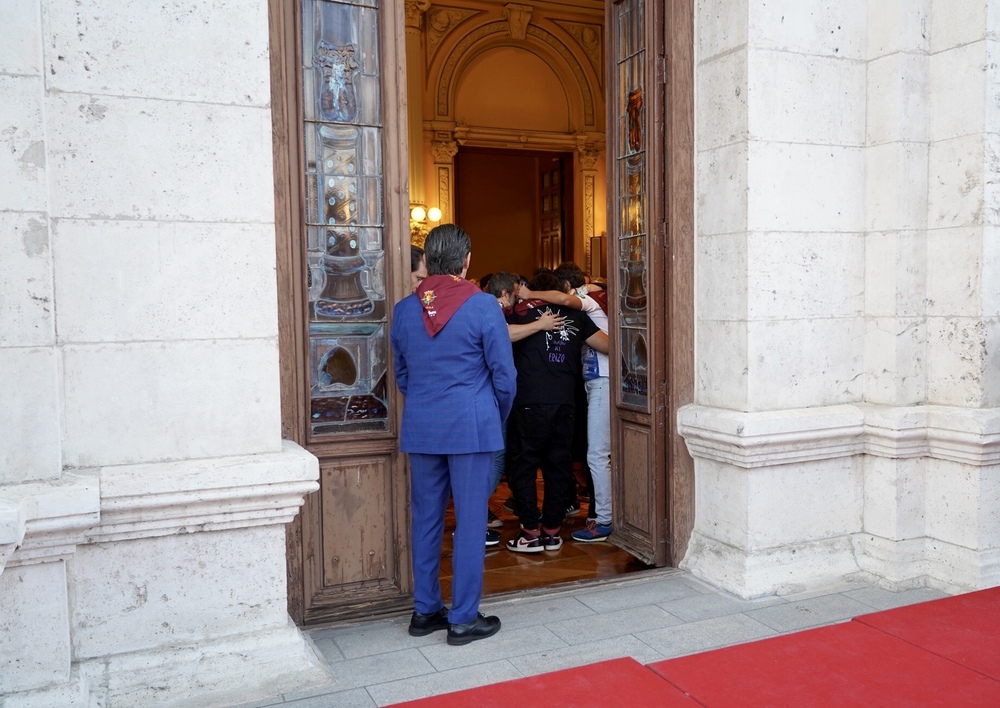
[[386, 588, 1000, 708]]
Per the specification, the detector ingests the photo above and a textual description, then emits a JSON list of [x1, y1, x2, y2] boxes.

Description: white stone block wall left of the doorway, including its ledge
[[0, 0, 318, 705]]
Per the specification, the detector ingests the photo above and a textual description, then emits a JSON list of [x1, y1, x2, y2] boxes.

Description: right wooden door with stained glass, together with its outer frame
[[607, 0, 694, 566]]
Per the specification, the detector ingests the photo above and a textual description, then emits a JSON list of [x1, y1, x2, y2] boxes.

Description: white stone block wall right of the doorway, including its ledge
[[680, 0, 1000, 596]]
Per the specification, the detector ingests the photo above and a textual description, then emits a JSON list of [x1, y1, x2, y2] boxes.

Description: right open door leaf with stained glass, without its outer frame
[[606, 0, 670, 565]]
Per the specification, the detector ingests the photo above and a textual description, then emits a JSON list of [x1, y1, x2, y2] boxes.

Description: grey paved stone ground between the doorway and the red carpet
[[232, 569, 946, 708]]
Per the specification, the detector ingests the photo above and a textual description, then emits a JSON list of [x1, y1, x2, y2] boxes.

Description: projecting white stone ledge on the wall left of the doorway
[[0, 441, 319, 572]]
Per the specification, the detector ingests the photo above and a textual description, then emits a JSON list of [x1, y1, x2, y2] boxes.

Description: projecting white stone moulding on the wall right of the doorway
[[678, 404, 1000, 469]]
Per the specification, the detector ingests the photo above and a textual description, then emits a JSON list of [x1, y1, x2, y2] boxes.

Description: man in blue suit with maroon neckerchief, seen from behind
[[390, 224, 517, 645]]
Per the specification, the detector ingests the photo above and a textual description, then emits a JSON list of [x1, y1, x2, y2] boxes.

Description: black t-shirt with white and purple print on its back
[[505, 301, 601, 406]]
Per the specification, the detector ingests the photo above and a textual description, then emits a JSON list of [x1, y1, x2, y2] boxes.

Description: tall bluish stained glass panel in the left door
[[302, 0, 389, 435]]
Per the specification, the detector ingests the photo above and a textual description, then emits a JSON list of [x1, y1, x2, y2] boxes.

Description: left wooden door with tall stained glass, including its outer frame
[[270, 0, 412, 623]]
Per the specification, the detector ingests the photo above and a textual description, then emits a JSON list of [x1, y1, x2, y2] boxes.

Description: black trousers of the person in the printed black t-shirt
[[507, 404, 574, 529]]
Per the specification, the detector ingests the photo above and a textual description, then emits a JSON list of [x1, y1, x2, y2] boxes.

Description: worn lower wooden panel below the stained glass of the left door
[[320, 459, 395, 586]]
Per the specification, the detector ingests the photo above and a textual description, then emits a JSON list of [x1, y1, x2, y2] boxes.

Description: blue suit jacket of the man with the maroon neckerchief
[[390, 293, 517, 454]]
